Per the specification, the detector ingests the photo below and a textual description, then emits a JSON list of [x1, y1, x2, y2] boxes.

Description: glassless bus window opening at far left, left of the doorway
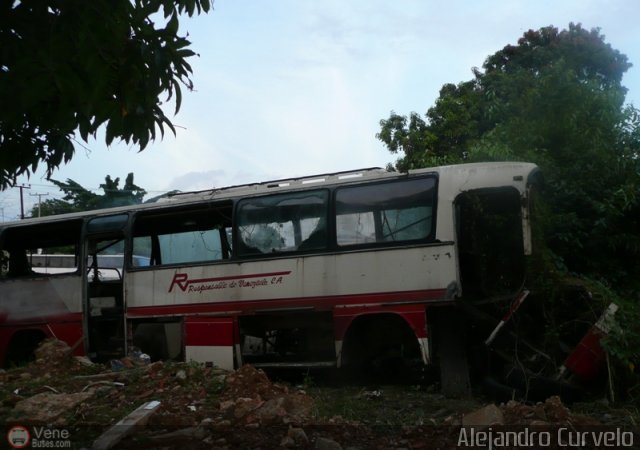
[[0, 220, 82, 278]]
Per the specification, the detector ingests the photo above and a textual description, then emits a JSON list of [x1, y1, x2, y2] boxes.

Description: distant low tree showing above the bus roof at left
[[31, 173, 147, 217]]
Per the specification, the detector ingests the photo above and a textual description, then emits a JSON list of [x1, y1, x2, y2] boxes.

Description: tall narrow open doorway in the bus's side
[[83, 214, 129, 362]]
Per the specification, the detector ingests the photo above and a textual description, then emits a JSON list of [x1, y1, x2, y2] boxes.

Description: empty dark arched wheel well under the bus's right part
[[342, 313, 421, 366]]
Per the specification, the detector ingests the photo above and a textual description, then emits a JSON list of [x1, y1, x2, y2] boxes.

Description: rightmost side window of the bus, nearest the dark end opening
[[336, 177, 436, 246]]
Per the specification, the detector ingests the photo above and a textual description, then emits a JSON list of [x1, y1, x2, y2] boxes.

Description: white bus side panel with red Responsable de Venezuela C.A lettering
[[125, 244, 456, 316]]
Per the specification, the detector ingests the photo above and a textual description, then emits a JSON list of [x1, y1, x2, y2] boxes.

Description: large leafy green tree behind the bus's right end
[[377, 24, 640, 287]]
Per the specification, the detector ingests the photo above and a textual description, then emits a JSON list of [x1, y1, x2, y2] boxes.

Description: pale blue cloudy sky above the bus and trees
[[0, 0, 640, 221]]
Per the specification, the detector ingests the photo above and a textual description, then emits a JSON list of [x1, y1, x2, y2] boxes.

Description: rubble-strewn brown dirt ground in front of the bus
[[0, 340, 640, 449]]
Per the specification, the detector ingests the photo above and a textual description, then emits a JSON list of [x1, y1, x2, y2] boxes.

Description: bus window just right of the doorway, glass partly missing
[[131, 203, 231, 267]]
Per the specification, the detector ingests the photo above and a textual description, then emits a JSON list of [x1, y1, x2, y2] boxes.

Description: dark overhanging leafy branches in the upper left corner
[[0, 0, 211, 189]]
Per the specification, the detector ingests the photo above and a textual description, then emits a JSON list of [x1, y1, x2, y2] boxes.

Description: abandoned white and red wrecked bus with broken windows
[[0, 162, 537, 384]]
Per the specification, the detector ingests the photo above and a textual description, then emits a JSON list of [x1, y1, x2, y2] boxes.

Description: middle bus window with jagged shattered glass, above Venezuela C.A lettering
[[237, 190, 329, 255]]
